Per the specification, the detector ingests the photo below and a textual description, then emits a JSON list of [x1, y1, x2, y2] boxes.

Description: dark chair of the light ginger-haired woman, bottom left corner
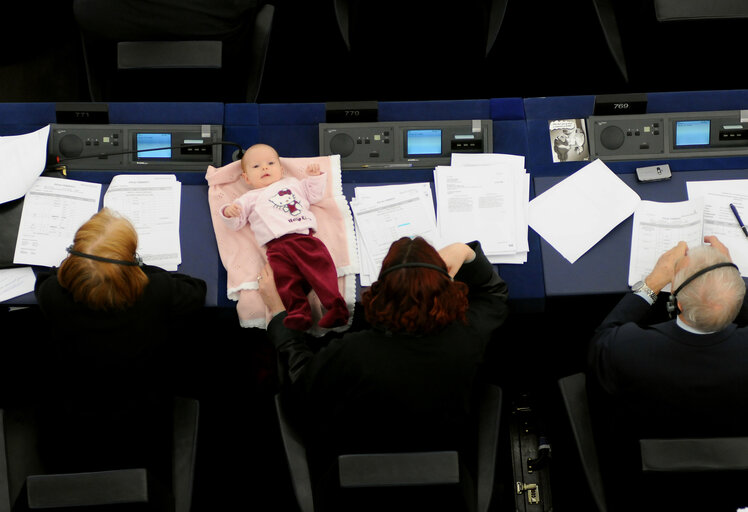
[[0, 398, 199, 512]]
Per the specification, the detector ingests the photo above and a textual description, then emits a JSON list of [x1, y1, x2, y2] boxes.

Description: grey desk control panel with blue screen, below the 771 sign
[[48, 124, 223, 172]]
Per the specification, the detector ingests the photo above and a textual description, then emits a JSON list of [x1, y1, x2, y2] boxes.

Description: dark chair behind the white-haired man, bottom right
[[558, 373, 748, 512]]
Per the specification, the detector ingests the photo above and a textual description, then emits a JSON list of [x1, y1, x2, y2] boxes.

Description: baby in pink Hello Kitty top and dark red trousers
[[221, 144, 348, 331]]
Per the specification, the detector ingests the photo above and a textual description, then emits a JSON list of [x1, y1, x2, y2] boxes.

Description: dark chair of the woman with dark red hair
[[275, 385, 502, 512]]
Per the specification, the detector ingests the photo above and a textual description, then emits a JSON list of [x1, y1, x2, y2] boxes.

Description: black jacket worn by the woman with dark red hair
[[268, 243, 507, 466]]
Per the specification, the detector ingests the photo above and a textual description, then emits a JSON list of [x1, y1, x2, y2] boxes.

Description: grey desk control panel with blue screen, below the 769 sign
[[587, 110, 748, 160]]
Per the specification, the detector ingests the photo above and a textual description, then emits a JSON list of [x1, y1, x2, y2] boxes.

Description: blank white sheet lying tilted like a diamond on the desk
[[529, 160, 641, 263]]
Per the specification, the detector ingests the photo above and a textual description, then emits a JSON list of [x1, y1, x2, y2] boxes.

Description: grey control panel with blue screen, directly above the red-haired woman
[[319, 119, 493, 169]]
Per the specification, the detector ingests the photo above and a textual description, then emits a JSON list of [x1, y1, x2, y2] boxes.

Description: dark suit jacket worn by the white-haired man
[[590, 293, 748, 436]]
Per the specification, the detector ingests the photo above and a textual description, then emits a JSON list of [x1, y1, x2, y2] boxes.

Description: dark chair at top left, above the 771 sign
[[74, 0, 275, 103]]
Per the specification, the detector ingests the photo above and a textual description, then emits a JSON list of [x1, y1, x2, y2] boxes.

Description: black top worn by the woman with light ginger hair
[[29, 266, 206, 481]]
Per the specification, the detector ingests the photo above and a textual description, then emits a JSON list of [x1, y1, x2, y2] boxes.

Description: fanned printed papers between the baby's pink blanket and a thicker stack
[[351, 183, 442, 286]]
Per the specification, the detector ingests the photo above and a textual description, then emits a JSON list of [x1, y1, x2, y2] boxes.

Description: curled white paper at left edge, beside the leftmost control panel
[[0, 125, 49, 203]]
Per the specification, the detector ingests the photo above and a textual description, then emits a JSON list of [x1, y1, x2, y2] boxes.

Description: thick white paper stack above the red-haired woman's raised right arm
[[434, 153, 530, 263]]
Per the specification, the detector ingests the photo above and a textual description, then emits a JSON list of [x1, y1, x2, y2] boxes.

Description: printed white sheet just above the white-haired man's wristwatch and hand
[[628, 198, 704, 291]]
